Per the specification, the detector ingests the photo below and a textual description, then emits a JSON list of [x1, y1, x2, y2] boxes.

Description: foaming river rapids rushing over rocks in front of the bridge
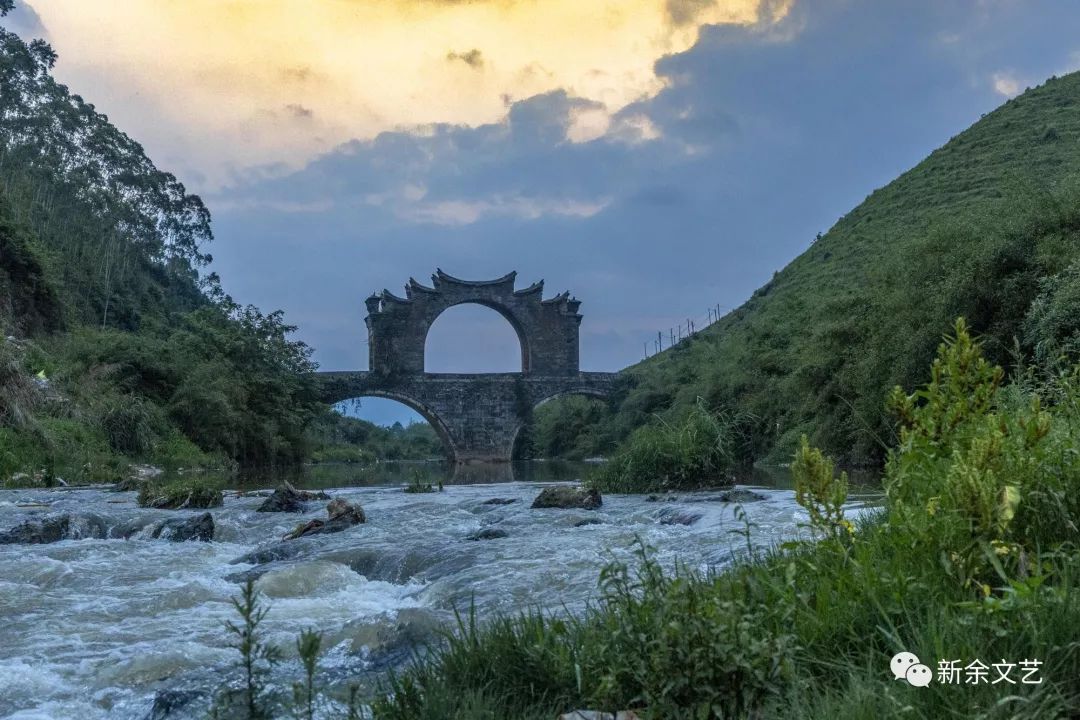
[[0, 463, 875, 720]]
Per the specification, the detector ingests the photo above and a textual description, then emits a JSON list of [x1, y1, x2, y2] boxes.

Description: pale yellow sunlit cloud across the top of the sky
[[30, 0, 793, 186]]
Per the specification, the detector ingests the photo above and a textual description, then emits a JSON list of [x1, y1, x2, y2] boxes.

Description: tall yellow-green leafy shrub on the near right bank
[[886, 320, 1080, 594]]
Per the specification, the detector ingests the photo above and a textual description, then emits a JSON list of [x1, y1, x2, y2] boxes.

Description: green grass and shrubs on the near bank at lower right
[[375, 323, 1080, 720]]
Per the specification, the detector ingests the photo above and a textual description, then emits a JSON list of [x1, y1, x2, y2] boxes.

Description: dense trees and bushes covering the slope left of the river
[[0, 2, 321, 483]]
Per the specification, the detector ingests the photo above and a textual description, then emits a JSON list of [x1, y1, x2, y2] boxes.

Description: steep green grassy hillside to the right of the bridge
[[544, 73, 1080, 463]]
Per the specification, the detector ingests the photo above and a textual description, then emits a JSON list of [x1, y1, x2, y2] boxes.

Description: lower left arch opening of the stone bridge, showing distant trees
[[324, 394, 454, 461]]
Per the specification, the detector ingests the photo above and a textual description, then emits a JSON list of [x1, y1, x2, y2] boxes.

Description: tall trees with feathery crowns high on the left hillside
[[0, 0, 213, 326]]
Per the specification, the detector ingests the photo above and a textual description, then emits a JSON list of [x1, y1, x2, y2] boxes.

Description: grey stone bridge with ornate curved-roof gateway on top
[[318, 270, 618, 464]]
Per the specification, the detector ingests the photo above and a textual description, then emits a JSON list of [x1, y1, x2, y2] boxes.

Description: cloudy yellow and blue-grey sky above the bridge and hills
[[6, 0, 1080, 420]]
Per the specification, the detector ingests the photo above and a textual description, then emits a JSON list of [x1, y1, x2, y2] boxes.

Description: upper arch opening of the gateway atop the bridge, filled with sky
[[423, 302, 529, 375]]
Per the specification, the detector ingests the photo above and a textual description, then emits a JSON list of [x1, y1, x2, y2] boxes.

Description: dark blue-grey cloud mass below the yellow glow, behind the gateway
[[210, 0, 1080, 423]]
